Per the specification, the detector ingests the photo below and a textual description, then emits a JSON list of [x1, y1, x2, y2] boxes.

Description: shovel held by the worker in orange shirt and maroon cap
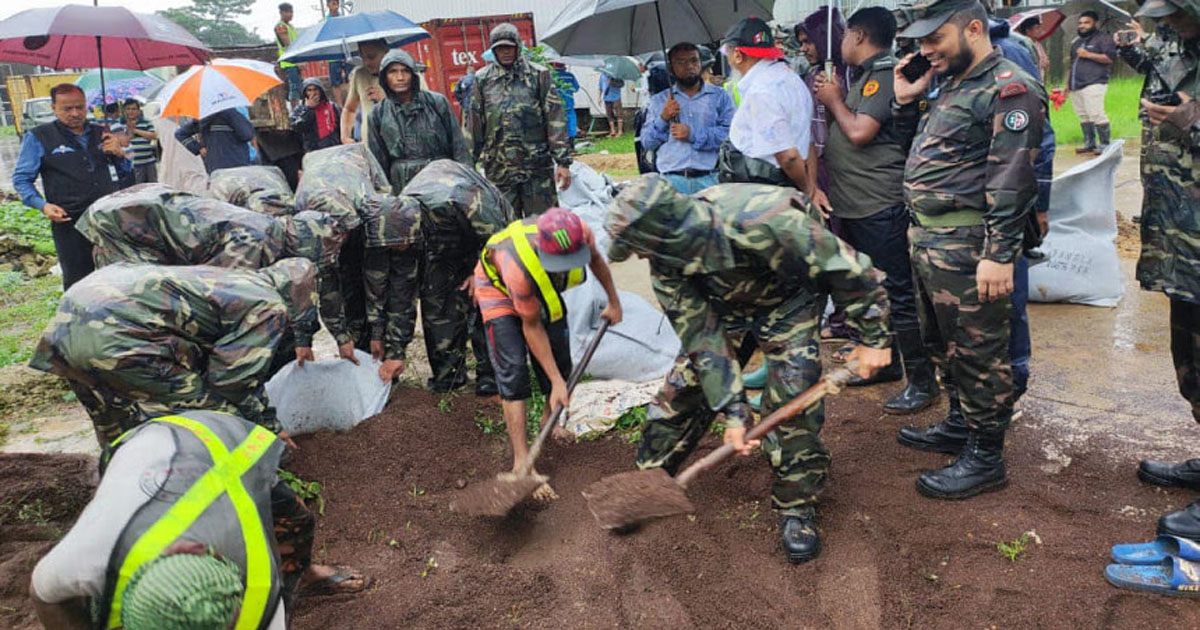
[[450, 319, 608, 516]]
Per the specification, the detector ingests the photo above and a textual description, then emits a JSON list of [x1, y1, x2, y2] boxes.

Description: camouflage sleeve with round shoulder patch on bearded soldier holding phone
[[983, 77, 1046, 263]]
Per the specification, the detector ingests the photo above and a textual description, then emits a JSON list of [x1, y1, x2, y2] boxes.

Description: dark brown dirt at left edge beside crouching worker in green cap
[[0, 454, 97, 630]]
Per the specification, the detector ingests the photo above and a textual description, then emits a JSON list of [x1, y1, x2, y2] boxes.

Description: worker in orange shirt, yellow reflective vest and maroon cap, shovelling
[[472, 208, 622, 496]]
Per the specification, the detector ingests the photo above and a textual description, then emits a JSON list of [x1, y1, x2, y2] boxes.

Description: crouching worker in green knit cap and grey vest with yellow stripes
[[30, 412, 368, 630]]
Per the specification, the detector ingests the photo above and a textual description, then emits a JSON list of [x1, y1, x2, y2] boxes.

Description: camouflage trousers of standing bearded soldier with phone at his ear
[[908, 226, 1013, 432]]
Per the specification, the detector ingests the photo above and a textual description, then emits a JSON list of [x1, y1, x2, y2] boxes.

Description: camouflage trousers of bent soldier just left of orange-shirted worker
[[421, 252, 496, 392]]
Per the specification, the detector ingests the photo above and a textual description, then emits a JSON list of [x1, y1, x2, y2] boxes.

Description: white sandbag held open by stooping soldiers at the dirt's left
[[266, 350, 391, 436]]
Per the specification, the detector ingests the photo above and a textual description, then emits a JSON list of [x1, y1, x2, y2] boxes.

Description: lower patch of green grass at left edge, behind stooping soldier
[[0, 271, 62, 367]]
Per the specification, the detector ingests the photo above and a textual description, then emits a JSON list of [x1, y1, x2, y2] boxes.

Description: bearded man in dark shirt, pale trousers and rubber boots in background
[[1067, 11, 1117, 155]]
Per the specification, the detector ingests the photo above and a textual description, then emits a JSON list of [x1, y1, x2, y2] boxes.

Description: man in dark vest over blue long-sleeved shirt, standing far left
[[12, 83, 133, 290]]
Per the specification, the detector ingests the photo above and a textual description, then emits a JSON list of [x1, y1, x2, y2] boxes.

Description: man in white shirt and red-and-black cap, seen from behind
[[721, 18, 829, 210]]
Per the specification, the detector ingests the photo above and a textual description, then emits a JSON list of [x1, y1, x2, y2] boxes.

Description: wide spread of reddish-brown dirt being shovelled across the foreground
[[290, 386, 1200, 630]]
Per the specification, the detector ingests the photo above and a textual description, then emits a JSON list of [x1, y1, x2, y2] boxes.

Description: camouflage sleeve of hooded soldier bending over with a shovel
[[746, 210, 890, 348]]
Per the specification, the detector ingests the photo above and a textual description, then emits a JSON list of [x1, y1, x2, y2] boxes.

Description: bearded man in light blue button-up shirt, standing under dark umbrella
[[641, 42, 733, 194]]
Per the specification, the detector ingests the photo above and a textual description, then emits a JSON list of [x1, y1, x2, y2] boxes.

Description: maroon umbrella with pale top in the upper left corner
[[0, 0, 210, 116]]
